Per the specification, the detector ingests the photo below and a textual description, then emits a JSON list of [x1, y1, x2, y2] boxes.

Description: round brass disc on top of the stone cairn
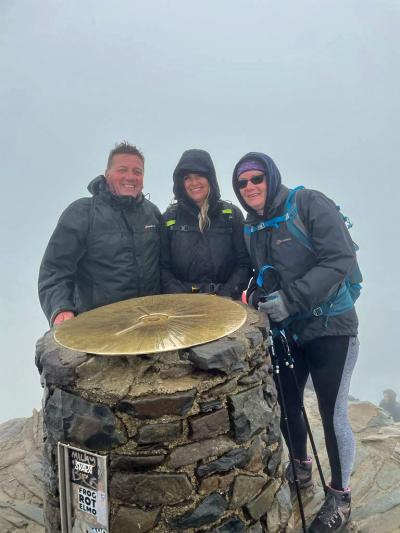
[[54, 294, 247, 355]]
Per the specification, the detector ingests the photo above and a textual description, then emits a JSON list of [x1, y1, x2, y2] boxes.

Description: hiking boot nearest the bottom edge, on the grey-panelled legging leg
[[308, 487, 351, 533]]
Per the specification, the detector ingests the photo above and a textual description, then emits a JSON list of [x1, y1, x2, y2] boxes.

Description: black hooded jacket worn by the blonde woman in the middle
[[161, 150, 250, 299]]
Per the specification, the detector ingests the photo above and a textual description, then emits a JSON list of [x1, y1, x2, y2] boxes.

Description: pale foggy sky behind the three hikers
[[0, 0, 400, 421]]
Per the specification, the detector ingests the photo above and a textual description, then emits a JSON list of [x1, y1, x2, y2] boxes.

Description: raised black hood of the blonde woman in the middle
[[174, 149, 221, 207]]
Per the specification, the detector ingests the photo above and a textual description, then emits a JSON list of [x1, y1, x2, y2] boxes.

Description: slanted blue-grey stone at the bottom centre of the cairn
[[172, 492, 227, 529]]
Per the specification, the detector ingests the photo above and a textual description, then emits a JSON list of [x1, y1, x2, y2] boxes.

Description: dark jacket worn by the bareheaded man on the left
[[39, 176, 161, 324]]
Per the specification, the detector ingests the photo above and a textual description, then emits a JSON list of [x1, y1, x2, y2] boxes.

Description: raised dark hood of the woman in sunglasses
[[232, 152, 283, 218]]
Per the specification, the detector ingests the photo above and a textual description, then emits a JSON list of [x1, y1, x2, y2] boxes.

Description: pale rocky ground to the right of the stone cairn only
[[295, 392, 400, 533]]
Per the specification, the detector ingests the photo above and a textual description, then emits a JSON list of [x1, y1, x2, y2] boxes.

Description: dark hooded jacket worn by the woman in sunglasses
[[232, 152, 358, 344]]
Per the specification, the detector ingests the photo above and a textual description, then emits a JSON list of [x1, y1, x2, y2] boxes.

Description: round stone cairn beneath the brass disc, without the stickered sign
[[36, 311, 291, 533]]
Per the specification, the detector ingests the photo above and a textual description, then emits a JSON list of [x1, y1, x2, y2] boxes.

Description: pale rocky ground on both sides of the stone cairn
[[0, 392, 400, 533]]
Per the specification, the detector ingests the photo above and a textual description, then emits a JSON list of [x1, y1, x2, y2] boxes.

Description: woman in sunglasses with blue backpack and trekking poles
[[232, 152, 361, 533]]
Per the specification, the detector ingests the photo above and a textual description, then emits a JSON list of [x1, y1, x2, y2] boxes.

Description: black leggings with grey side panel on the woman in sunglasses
[[274, 336, 358, 490]]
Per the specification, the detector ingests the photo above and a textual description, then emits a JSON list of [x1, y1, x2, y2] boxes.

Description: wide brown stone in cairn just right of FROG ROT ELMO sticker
[[110, 472, 193, 506]]
